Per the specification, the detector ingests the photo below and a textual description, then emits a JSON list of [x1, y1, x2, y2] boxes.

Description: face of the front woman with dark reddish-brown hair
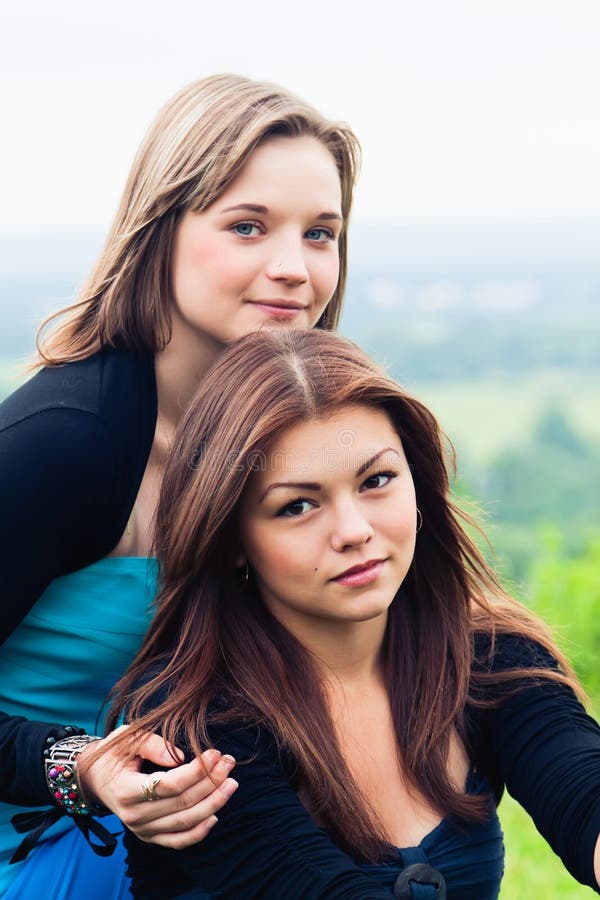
[[240, 406, 416, 638]]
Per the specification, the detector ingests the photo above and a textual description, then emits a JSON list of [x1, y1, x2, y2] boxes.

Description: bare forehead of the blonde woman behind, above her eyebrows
[[216, 135, 342, 212]]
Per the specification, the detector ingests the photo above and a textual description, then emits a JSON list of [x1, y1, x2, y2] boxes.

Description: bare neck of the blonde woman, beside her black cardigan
[[154, 319, 223, 432]]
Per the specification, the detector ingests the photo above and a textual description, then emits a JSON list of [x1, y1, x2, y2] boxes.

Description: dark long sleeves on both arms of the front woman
[[126, 636, 600, 900]]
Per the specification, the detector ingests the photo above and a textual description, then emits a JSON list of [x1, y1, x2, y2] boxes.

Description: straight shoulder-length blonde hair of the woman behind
[[38, 75, 360, 365]]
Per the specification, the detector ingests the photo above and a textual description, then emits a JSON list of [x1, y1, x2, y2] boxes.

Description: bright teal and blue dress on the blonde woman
[[0, 556, 156, 900]]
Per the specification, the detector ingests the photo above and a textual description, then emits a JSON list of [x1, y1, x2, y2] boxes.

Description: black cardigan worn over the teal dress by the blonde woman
[[0, 348, 157, 806]]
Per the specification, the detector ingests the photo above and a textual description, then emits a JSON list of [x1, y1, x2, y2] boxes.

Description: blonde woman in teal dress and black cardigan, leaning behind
[[0, 75, 358, 900]]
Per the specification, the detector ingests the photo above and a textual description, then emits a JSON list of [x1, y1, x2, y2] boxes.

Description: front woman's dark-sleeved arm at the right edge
[[475, 635, 600, 893]]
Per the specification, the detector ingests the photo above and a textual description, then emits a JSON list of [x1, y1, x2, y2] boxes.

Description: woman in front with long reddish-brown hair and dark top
[[112, 331, 600, 900]]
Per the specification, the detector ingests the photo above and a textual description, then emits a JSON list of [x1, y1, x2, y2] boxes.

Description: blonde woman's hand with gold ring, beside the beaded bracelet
[[78, 725, 237, 850]]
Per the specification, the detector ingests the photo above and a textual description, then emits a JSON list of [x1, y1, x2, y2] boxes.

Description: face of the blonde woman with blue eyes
[[172, 136, 342, 346]]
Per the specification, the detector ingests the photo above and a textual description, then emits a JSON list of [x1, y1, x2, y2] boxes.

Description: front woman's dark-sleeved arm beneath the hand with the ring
[[126, 726, 391, 900]]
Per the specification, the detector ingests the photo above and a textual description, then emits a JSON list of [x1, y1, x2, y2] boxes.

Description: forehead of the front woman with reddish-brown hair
[[258, 405, 403, 484]]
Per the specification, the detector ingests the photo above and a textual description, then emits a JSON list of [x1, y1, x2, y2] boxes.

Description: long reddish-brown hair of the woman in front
[[111, 331, 580, 860]]
